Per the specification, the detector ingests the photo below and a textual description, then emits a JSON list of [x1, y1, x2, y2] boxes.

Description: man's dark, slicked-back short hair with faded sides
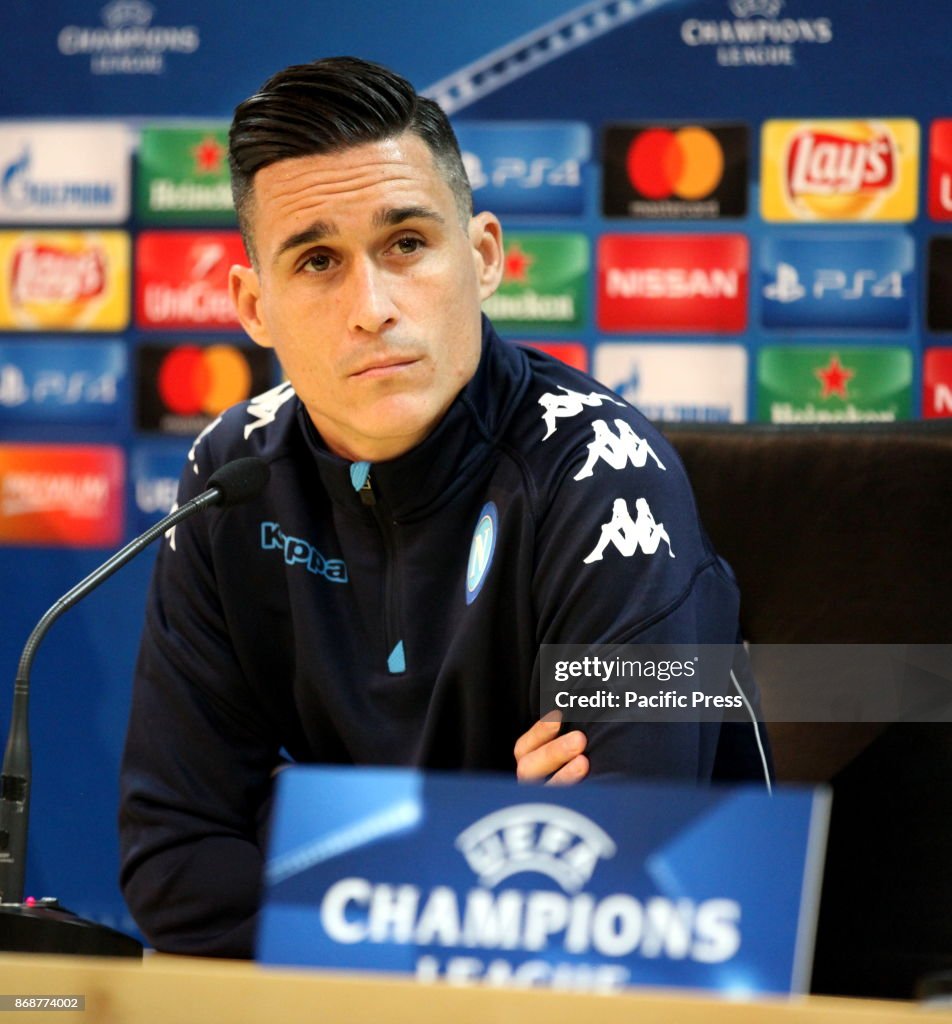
[[228, 57, 473, 260]]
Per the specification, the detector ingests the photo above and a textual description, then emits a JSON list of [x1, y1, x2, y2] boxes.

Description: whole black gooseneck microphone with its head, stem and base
[[0, 457, 270, 955]]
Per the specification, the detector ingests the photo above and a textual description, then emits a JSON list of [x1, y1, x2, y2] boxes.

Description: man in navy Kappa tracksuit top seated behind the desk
[[121, 58, 764, 956]]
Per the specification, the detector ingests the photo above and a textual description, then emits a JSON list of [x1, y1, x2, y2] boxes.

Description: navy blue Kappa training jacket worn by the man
[[120, 322, 763, 956]]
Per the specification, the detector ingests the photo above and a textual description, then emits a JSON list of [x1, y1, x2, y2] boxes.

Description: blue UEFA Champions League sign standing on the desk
[[258, 767, 828, 993]]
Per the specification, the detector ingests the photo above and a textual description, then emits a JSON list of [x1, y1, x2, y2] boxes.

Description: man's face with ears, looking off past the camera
[[231, 133, 502, 461]]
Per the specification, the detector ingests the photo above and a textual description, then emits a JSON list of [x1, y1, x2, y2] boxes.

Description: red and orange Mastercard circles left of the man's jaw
[[157, 345, 252, 416]]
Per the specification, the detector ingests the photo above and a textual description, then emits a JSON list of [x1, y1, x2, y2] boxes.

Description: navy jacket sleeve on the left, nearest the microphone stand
[[120, 460, 278, 956]]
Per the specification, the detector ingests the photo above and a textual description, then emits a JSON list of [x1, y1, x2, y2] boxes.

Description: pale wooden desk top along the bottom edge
[[0, 954, 952, 1024]]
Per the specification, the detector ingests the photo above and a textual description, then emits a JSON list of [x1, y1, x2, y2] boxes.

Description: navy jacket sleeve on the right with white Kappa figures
[[535, 413, 769, 782]]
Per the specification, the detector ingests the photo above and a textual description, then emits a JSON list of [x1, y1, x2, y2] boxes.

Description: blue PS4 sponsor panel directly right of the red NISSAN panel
[[761, 230, 915, 331]]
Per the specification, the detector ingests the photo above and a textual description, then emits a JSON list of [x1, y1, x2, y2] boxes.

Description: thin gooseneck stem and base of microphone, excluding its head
[[0, 486, 222, 957]]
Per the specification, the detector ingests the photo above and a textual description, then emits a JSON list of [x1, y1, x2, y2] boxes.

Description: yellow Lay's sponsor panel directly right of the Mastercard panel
[[762, 120, 919, 221]]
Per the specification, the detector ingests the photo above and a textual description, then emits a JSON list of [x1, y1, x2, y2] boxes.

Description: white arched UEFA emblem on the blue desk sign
[[456, 804, 616, 893]]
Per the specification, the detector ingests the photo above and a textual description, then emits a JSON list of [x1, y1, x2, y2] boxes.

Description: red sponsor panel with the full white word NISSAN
[[598, 234, 749, 333]]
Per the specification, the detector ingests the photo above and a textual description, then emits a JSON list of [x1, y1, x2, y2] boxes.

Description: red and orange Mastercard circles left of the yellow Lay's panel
[[625, 126, 724, 200]]
